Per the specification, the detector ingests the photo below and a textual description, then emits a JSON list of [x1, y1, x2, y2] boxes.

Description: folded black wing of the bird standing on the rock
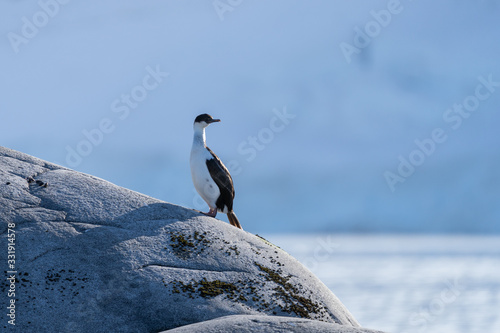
[[207, 147, 234, 211]]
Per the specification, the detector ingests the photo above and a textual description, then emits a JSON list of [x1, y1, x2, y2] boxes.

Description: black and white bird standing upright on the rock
[[190, 113, 242, 229]]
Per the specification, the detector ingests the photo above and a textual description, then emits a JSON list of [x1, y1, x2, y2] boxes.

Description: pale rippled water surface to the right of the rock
[[272, 234, 500, 333]]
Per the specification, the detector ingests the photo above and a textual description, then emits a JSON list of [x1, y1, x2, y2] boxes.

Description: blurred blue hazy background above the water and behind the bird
[[0, 0, 500, 233]]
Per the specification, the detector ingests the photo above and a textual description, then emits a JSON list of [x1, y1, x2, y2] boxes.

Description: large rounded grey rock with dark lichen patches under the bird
[[0, 147, 382, 332]]
